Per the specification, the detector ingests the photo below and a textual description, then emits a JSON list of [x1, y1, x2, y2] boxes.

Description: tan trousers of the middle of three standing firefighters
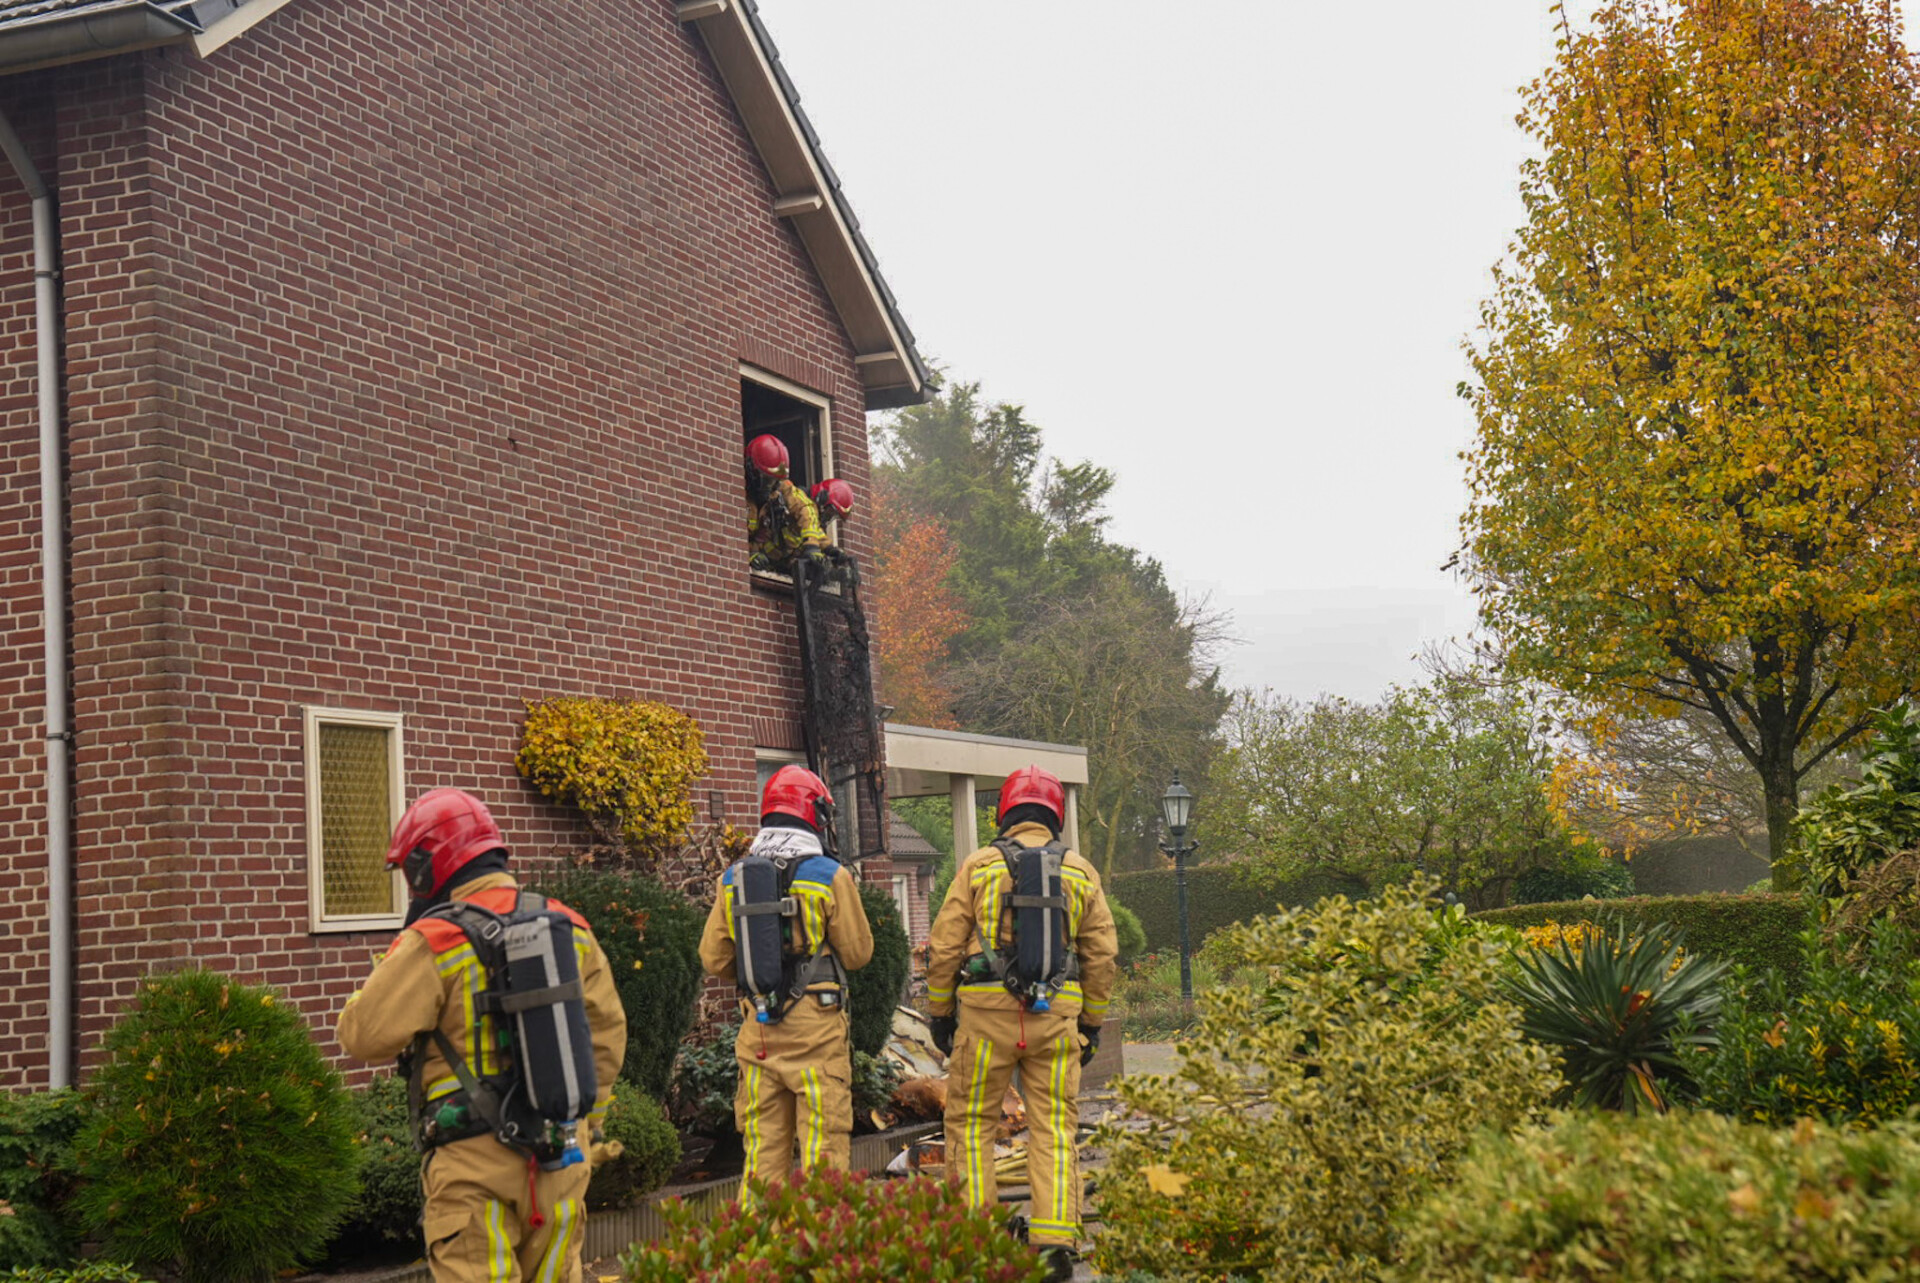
[[733, 995, 852, 1181]]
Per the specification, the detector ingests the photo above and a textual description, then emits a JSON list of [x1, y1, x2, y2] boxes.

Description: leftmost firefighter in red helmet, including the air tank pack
[[340, 789, 626, 1283]]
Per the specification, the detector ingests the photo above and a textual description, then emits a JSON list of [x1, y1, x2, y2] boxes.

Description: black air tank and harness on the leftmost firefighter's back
[[401, 891, 597, 1172]]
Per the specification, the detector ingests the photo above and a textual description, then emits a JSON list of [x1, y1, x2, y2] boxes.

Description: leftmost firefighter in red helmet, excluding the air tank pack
[[340, 789, 626, 1283]]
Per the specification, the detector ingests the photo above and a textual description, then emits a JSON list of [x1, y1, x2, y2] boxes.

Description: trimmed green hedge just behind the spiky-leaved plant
[[1475, 895, 1816, 993]]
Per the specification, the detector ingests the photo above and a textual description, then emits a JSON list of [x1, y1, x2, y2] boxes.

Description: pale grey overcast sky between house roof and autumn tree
[[760, 0, 1643, 697]]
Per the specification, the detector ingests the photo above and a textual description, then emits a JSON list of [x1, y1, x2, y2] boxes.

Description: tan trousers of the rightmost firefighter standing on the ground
[[947, 1003, 1081, 1247]]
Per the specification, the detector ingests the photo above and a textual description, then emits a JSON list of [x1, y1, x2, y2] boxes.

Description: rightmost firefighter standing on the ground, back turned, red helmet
[[927, 766, 1119, 1279]]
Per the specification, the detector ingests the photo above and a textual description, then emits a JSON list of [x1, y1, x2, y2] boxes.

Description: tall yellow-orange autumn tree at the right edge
[[1463, 0, 1920, 884]]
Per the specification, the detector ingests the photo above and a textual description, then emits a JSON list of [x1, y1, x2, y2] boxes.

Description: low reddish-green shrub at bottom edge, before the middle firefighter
[[620, 1168, 1044, 1283]]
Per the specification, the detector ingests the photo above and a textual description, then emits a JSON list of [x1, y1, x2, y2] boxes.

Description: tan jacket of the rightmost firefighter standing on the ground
[[927, 824, 1119, 1024]]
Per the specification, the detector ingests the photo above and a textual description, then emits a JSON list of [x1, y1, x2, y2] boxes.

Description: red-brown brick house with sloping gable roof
[[0, 0, 925, 1087]]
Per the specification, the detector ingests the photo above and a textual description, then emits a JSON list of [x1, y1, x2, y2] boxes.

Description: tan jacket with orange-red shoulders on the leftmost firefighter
[[340, 874, 626, 1126]]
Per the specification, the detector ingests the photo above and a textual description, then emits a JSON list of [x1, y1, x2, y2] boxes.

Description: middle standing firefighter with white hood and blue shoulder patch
[[701, 766, 874, 1198]]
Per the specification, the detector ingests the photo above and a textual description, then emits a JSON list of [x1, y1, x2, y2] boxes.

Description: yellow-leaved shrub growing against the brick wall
[[515, 695, 707, 855]]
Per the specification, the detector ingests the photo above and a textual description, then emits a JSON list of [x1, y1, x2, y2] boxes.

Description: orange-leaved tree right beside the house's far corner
[[872, 478, 972, 730]]
